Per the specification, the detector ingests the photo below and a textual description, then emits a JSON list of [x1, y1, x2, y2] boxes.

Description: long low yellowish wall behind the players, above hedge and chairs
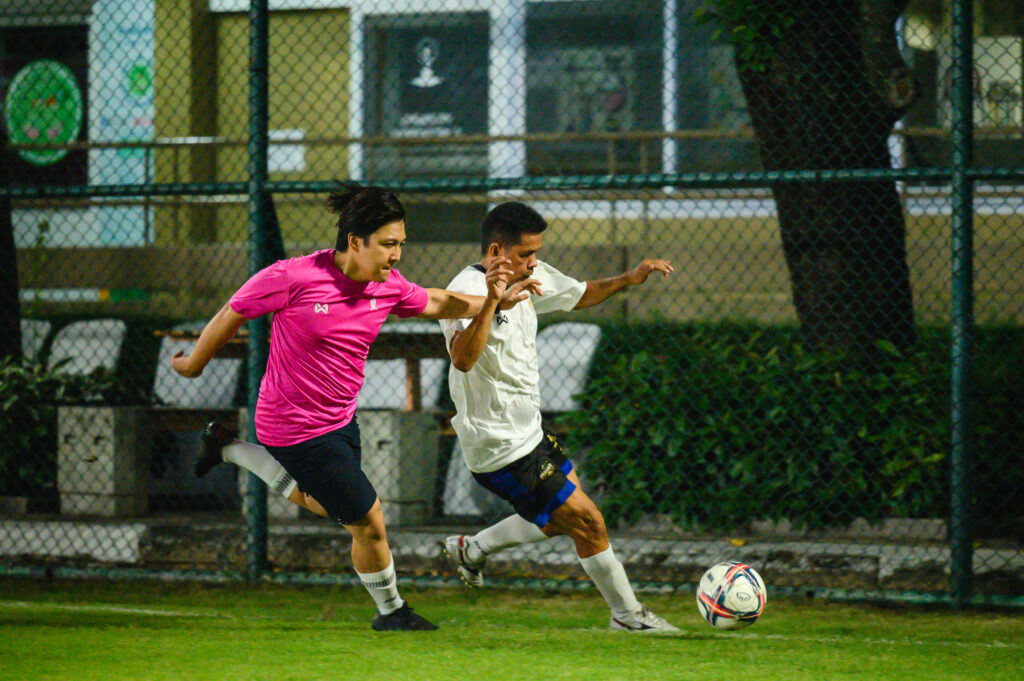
[[18, 208, 1024, 325]]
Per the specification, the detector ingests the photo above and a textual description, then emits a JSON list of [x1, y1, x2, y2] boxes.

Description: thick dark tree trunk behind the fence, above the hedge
[[736, 0, 915, 352]]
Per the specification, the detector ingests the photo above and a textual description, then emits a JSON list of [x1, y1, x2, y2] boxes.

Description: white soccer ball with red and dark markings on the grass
[[697, 560, 768, 629]]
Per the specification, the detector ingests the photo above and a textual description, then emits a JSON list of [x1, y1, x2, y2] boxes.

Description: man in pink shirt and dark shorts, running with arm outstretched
[[171, 184, 536, 630]]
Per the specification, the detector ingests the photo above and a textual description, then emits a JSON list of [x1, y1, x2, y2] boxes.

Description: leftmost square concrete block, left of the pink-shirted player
[[57, 407, 153, 517]]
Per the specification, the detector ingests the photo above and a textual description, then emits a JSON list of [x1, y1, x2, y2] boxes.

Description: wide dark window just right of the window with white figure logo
[[526, 0, 663, 175]]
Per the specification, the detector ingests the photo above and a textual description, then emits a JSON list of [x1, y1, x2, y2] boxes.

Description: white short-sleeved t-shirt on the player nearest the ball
[[440, 262, 587, 473]]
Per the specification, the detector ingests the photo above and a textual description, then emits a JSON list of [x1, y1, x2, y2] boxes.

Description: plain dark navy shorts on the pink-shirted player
[[266, 417, 377, 525]]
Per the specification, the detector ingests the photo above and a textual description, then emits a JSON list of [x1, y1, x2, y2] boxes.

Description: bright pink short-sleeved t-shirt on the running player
[[228, 249, 427, 446]]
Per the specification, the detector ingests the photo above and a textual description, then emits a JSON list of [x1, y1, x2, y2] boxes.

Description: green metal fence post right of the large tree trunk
[[949, 0, 974, 607]]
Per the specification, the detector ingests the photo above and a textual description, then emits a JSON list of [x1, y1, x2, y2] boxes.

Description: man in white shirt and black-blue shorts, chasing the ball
[[440, 202, 678, 633]]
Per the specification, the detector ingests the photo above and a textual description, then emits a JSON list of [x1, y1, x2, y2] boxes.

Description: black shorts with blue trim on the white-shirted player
[[473, 431, 575, 527]]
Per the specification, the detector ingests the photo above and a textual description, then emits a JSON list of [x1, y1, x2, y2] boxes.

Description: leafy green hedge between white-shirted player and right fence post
[[562, 325, 949, 530]]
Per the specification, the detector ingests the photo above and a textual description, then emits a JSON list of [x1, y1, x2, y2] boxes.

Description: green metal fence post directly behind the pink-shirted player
[[246, 0, 269, 581]]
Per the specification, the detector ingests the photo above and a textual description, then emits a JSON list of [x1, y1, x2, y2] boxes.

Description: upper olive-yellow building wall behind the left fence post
[[155, 5, 348, 244]]
